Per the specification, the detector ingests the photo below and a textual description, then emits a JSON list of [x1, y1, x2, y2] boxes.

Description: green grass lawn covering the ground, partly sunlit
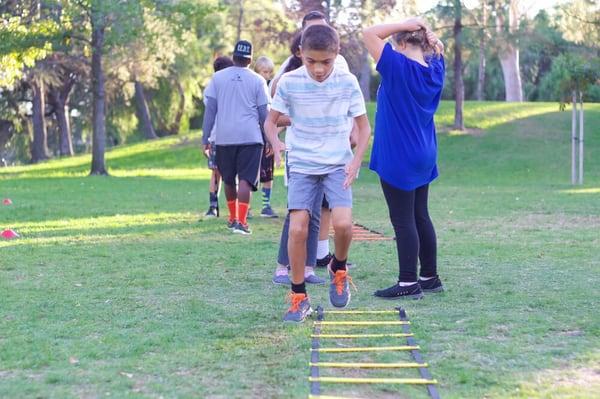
[[0, 102, 600, 398]]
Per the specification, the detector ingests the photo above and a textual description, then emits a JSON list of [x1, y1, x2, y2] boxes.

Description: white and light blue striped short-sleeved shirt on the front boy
[[271, 66, 366, 175]]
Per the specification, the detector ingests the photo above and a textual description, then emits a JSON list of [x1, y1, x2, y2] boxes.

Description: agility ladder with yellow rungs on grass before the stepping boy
[[308, 306, 440, 399]]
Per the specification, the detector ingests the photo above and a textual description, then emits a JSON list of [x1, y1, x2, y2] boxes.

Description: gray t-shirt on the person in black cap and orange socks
[[204, 66, 270, 145]]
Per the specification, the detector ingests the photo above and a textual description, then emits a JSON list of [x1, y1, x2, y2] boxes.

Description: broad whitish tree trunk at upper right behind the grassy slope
[[496, 0, 523, 102]]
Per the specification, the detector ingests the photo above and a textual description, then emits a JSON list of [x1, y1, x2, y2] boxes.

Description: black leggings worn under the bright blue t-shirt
[[381, 180, 437, 282]]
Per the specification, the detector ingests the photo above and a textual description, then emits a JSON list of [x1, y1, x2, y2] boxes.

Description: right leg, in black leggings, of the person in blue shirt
[[415, 184, 437, 278]]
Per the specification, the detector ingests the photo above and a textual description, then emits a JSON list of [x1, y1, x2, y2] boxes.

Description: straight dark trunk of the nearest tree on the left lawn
[[90, 16, 108, 175]]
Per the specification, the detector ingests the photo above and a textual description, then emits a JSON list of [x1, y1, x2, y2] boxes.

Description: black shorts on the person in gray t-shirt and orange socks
[[217, 144, 263, 191]]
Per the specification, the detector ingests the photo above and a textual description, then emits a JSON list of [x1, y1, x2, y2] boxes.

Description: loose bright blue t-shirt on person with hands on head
[[370, 33, 445, 190]]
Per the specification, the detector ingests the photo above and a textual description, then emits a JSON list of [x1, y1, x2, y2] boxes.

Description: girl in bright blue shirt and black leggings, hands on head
[[363, 19, 445, 299]]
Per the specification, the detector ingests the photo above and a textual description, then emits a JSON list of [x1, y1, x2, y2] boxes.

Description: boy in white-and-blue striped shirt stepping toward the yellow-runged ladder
[[265, 25, 371, 322]]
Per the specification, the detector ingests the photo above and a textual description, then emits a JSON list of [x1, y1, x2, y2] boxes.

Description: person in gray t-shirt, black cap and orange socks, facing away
[[202, 40, 270, 234]]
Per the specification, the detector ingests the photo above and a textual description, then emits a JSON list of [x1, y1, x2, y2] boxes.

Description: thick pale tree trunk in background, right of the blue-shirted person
[[494, 0, 523, 102]]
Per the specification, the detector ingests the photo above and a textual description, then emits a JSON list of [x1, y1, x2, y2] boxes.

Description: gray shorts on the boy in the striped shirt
[[288, 169, 352, 212]]
